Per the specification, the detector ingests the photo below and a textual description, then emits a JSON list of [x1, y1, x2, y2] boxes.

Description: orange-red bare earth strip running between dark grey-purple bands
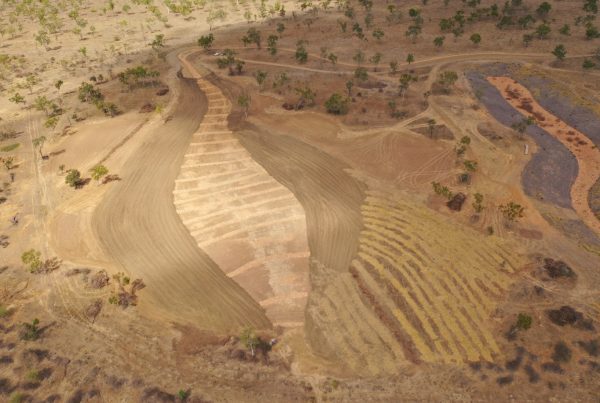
[[488, 77, 600, 234]]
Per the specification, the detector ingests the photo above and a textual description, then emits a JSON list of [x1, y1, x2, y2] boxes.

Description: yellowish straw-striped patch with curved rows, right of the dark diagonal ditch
[[351, 191, 521, 363]]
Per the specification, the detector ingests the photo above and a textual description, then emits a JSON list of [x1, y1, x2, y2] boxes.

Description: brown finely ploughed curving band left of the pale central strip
[[92, 52, 271, 331]]
